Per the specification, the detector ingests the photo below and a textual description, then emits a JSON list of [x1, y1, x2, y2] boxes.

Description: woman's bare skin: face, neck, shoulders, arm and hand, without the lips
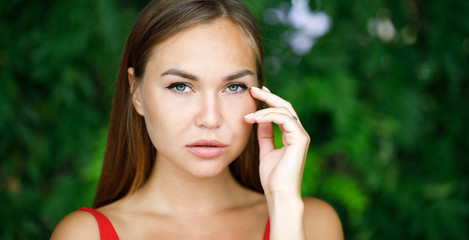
[[51, 19, 343, 239]]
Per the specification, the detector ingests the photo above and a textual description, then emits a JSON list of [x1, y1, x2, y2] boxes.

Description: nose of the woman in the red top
[[195, 94, 223, 129]]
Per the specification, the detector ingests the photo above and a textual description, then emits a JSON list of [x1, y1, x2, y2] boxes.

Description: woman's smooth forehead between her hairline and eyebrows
[[147, 19, 256, 75]]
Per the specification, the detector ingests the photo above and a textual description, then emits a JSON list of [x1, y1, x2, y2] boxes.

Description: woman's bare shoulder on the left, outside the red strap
[[51, 211, 100, 240]]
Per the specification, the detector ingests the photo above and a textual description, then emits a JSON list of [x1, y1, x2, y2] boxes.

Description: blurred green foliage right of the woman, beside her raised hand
[[256, 0, 469, 239]]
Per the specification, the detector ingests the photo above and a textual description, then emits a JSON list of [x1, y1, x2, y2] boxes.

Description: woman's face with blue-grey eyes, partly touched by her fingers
[[129, 19, 257, 177]]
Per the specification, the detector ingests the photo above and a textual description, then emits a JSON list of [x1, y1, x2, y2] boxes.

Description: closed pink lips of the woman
[[186, 140, 228, 158]]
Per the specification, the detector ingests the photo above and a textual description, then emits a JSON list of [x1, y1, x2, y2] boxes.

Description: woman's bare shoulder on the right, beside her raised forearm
[[303, 197, 344, 240]]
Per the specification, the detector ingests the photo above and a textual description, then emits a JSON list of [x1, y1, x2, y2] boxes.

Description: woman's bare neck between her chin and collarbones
[[131, 156, 249, 215]]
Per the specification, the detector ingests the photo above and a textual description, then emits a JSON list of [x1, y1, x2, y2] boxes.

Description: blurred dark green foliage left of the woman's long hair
[[0, 0, 141, 239]]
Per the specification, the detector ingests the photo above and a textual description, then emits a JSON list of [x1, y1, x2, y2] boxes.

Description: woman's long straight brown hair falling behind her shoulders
[[93, 0, 264, 208]]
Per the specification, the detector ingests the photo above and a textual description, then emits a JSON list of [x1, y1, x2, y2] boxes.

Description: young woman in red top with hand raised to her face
[[52, 0, 343, 240]]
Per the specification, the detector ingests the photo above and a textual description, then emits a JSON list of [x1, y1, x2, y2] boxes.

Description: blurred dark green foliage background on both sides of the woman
[[0, 0, 469, 239]]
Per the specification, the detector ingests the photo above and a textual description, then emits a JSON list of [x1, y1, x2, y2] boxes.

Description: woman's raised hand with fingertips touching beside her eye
[[245, 87, 310, 198]]
